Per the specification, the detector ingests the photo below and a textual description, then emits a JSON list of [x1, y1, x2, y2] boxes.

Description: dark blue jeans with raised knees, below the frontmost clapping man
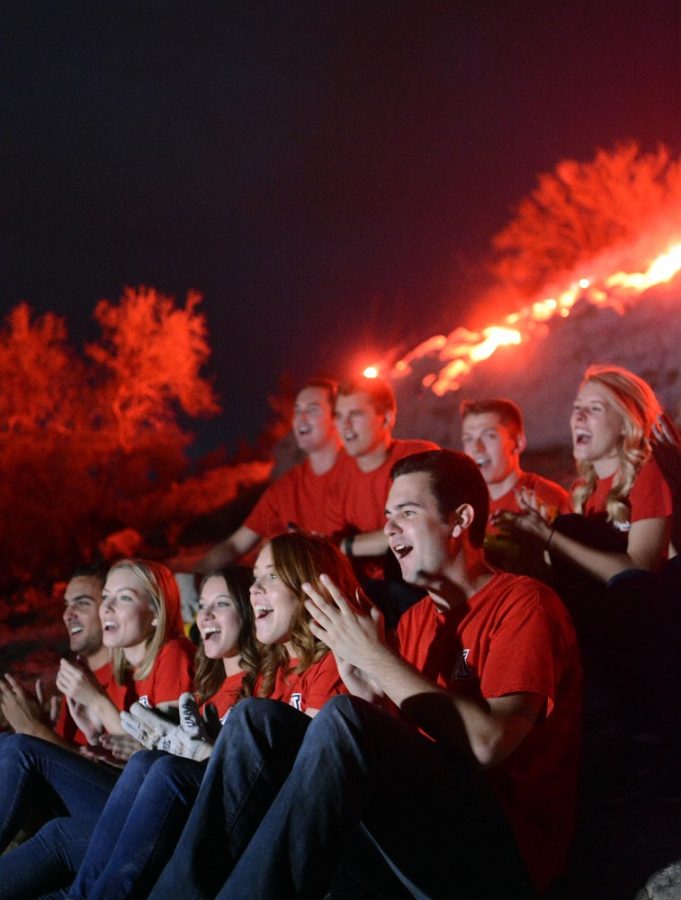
[[151, 696, 534, 900]]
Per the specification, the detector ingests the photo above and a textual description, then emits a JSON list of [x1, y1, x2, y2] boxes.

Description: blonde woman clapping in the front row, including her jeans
[[0, 560, 194, 900]]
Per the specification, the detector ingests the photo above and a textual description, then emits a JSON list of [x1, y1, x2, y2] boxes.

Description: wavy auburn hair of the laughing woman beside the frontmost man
[[258, 531, 368, 697]]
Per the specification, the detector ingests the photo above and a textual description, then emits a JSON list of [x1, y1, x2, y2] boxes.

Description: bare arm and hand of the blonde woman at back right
[[495, 506, 667, 583]]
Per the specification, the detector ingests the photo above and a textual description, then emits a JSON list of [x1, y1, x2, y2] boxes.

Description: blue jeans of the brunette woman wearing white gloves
[[68, 750, 206, 900]]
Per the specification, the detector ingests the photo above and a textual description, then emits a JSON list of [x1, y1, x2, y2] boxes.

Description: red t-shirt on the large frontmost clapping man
[[397, 573, 581, 889]]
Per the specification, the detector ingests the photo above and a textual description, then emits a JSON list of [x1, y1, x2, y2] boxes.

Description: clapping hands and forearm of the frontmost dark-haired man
[[305, 576, 546, 766]]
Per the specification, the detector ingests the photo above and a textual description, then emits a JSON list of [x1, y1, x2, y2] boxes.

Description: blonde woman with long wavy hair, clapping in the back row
[[499, 365, 672, 583]]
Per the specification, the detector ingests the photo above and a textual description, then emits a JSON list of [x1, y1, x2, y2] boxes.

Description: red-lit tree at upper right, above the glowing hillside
[[493, 142, 681, 294]]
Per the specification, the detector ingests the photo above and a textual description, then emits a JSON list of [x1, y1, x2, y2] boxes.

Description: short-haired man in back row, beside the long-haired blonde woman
[[461, 398, 572, 531]]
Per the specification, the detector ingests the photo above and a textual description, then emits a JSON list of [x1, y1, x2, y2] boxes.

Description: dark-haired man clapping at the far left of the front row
[[0, 565, 113, 746]]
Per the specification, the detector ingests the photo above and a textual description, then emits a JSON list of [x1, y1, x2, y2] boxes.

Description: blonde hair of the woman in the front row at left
[[107, 559, 180, 684]]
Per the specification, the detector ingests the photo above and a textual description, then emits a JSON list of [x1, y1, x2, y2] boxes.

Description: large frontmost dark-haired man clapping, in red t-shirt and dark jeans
[[151, 450, 580, 900]]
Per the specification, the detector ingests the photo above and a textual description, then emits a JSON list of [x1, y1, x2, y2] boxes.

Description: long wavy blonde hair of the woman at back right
[[573, 365, 662, 522]]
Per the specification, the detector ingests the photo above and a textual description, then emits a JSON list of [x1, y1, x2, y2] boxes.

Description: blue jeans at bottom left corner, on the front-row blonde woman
[[0, 734, 118, 900]]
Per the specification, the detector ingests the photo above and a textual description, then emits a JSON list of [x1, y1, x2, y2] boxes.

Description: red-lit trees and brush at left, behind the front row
[[0, 288, 270, 585]]
